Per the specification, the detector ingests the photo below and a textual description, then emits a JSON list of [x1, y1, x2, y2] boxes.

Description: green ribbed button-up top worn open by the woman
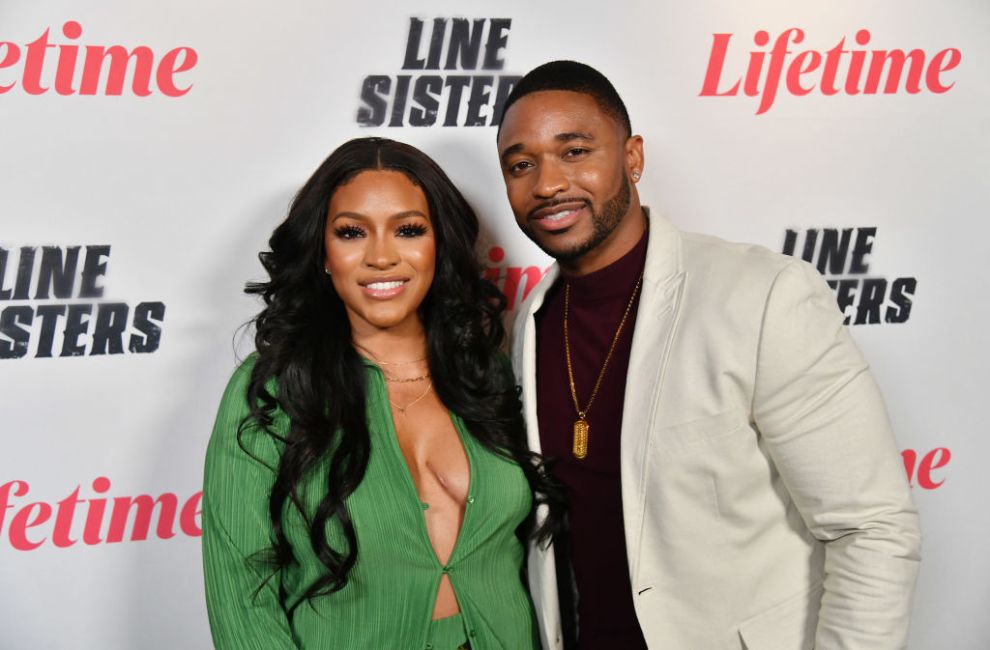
[[203, 355, 537, 650]]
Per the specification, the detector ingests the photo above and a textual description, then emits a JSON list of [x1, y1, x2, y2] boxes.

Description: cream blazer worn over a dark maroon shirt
[[512, 215, 921, 650]]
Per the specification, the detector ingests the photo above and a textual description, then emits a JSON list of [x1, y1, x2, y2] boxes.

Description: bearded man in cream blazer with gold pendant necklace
[[498, 61, 920, 650]]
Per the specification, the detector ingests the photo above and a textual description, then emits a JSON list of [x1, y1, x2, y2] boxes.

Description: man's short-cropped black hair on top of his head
[[498, 61, 632, 137]]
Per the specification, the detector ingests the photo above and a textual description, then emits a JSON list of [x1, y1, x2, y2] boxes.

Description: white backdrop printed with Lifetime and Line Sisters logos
[[0, 0, 990, 650]]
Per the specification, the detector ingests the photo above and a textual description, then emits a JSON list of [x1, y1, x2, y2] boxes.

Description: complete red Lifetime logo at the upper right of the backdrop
[[700, 27, 962, 115]]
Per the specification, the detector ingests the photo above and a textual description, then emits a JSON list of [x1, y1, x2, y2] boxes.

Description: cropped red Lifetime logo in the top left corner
[[0, 20, 199, 97]]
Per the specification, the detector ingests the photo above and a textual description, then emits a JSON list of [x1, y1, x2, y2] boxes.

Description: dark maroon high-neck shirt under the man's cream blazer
[[535, 225, 647, 650]]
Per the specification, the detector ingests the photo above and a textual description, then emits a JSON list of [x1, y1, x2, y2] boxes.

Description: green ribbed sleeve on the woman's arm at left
[[203, 359, 298, 650]]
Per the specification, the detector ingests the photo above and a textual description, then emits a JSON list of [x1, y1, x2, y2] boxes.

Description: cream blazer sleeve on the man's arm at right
[[753, 260, 921, 650]]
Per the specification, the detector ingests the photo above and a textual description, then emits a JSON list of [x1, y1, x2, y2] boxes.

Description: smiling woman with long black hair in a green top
[[203, 138, 553, 650]]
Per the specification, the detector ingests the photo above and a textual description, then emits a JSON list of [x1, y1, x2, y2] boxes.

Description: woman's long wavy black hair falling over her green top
[[238, 138, 562, 615]]
